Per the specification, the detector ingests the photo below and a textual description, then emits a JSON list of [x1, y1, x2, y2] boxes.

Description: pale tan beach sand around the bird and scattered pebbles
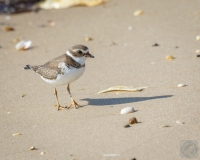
[[0, 0, 200, 160]]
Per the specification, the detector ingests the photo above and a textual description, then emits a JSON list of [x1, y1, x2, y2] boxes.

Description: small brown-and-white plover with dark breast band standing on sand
[[23, 44, 94, 111]]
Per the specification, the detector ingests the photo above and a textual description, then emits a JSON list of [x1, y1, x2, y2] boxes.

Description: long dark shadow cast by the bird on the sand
[[81, 95, 173, 106]]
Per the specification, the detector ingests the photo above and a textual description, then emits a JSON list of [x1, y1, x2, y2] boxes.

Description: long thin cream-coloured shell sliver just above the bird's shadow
[[98, 86, 148, 94]]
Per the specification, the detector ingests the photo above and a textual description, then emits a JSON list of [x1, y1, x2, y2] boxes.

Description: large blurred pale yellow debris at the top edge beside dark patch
[[39, 0, 108, 9]]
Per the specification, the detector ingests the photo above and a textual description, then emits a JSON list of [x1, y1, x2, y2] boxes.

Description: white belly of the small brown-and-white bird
[[41, 67, 85, 86]]
